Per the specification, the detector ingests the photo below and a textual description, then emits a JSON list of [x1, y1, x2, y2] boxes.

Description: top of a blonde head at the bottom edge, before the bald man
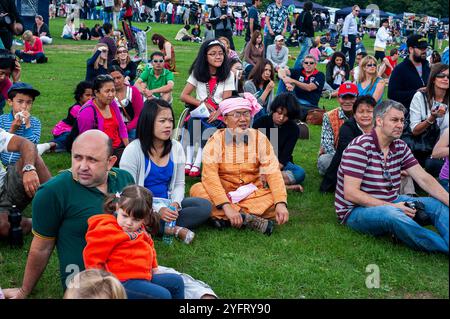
[[64, 269, 127, 299]]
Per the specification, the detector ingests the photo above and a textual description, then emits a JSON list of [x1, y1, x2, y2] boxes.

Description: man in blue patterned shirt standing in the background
[[264, 0, 289, 55]]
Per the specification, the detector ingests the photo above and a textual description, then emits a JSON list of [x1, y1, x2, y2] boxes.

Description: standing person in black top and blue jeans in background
[[294, 1, 314, 68]]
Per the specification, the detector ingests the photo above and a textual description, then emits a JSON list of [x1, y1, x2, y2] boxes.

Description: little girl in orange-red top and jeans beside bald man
[[83, 185, 184, 299]]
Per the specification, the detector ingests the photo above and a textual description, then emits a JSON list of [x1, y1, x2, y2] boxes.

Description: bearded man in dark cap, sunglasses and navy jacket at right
[[388, 34, 430, 114]]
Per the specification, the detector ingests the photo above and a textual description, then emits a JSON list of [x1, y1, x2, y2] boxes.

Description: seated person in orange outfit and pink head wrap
[[190, 93, 289, 235]]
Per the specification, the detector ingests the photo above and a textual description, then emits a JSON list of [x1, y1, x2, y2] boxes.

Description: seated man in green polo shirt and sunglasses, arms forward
[[134, 52, 174, 103]]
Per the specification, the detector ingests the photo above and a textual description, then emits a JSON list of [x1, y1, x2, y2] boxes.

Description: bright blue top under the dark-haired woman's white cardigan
[[144, 157, 174, 198]]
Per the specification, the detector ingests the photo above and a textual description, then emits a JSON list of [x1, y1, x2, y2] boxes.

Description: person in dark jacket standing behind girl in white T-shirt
[[209, 0, 234, 50]]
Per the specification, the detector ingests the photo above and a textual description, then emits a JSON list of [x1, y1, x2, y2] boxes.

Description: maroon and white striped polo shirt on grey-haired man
[[334, 129, 418, 223]]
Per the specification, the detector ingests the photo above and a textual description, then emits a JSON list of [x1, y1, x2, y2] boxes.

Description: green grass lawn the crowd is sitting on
[[0, 19, 449, 299]]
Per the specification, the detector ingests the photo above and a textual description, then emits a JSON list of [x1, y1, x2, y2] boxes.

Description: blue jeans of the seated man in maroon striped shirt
[[346, 195, 449, 254]]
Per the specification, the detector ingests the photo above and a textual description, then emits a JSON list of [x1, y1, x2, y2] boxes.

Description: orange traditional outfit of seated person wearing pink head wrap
[[190, 129, 287, 219]]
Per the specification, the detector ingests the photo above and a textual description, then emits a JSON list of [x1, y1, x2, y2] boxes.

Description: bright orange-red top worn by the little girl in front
[[83, 214, 158, 281]]
